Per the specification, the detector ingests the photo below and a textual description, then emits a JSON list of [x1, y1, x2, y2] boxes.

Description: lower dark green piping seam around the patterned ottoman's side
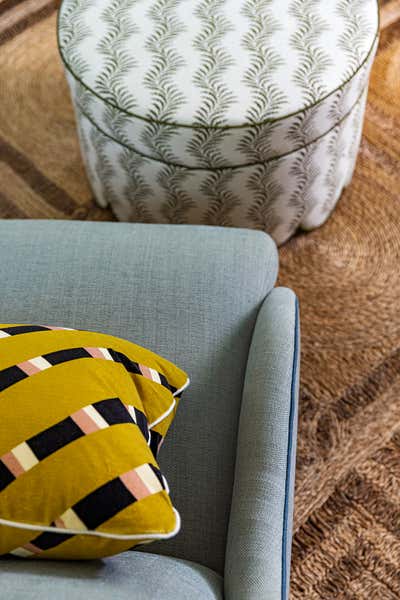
[[76, 83, 368, 172]]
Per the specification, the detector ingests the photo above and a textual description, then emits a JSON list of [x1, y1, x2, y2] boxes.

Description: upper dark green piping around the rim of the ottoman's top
[[57, 0, 380, 130]]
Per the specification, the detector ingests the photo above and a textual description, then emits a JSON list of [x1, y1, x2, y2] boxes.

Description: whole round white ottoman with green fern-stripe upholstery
[[58, 0, 378, 243]]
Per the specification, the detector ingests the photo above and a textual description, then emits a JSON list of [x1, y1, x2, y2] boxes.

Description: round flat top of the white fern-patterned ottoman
[[59, 0, 378, 128]]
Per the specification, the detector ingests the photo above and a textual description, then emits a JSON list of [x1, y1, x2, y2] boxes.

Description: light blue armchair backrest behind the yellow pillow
[[0, 221, 277, 572]]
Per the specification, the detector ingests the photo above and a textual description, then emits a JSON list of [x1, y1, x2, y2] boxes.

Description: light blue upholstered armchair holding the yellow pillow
[[0, 221, 299, 600]]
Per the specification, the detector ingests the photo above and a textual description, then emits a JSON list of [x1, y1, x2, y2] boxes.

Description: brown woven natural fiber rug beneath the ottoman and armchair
[[0, 0, 400, 600]]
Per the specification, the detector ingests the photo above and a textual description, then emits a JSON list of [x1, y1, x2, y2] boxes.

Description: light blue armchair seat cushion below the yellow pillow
[[1, 552, 223, 600]]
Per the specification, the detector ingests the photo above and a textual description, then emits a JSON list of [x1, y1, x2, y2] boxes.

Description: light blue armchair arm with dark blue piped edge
[[225, 288, 299, 600]]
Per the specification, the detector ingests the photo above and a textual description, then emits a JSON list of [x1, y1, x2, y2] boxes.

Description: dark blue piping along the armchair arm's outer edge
[[281, 298, 299, 600]]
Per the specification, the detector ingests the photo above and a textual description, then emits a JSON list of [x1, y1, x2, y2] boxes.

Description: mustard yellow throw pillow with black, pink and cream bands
[[0, 325, 189, 559]]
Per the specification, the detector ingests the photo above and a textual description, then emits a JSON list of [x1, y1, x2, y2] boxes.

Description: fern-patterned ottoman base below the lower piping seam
[[77, 90, 367, 244]]
